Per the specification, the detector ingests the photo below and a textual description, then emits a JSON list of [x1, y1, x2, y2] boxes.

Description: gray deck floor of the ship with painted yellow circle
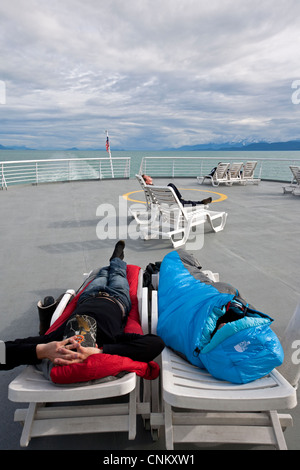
[[0, 179, 300, 450]]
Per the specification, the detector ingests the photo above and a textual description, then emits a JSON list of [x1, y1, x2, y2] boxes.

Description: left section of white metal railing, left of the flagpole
[[0, 157, 130, 189]]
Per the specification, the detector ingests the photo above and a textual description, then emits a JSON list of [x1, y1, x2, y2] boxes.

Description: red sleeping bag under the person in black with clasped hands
[[46, 265, 159, 384]]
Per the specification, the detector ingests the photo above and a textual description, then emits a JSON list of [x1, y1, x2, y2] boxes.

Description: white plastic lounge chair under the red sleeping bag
[[8, 270, 154, 447]]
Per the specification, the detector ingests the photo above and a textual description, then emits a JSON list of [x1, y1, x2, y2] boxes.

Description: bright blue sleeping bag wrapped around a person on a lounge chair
[[157, 250, 283, 383]]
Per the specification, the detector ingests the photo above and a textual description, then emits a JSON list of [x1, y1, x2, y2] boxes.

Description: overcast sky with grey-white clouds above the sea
[[0, 0, 300, 150]]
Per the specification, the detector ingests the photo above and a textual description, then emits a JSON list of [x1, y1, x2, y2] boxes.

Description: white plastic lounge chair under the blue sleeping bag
[[151, 275, 300, 450]]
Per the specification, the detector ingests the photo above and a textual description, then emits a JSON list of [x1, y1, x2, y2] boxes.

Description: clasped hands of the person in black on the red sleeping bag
[[36, 336, 102, 365]]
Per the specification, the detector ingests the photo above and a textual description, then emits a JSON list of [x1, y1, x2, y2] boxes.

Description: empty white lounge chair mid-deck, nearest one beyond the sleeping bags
[[140, 186, 227, 248]]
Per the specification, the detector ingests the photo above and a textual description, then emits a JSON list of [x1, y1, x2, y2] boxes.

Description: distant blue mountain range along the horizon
[[0, 140, 300, 152]]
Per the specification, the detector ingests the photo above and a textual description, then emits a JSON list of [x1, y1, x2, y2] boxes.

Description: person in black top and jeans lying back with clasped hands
[[0, 240, 164, 370]]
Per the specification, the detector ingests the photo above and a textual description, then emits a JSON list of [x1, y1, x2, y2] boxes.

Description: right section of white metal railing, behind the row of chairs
[[139, 154, 300, 182]]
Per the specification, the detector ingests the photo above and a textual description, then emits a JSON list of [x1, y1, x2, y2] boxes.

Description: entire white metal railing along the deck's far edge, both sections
[[0, 153, 300, 189]]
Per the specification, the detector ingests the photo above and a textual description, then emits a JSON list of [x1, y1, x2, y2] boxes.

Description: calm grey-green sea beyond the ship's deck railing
[[0, 150, 300, 178]]
